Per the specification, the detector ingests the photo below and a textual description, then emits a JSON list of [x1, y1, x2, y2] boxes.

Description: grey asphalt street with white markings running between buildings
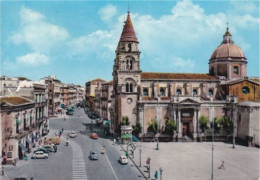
[[5, 108, 144, 180]]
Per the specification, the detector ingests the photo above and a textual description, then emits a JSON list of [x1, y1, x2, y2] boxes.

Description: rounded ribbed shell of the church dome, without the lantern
[[210, 43, 245, 59]]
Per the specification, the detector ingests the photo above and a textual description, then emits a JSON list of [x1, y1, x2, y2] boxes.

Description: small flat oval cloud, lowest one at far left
[[16, 53, 49, 66]]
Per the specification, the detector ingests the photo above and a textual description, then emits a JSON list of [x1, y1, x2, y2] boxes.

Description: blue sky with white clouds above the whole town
[[0, 0, 260, 85]]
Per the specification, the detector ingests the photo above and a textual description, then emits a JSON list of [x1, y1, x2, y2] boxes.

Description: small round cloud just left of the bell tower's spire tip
[[98, 4, 117, 22]]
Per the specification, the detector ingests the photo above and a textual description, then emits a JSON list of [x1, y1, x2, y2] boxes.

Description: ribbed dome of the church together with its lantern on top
[[210, 28, 245, 59]]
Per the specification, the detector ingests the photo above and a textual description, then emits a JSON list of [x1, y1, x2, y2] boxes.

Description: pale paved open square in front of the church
[[119, 142, 259, 180]]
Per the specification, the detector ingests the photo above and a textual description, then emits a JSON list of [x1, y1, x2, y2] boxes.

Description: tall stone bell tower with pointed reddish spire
[[112, 11, 141, 128]]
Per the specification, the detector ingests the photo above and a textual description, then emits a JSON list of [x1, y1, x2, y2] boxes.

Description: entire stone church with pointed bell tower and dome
[[110, 12, 259, 143]]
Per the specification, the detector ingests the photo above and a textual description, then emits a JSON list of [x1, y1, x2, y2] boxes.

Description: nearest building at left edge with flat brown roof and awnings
[[0, 96, 35, 163]]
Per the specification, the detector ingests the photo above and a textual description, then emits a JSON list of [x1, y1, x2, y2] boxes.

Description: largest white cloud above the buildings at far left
[[11, 7, 69, 53]]
